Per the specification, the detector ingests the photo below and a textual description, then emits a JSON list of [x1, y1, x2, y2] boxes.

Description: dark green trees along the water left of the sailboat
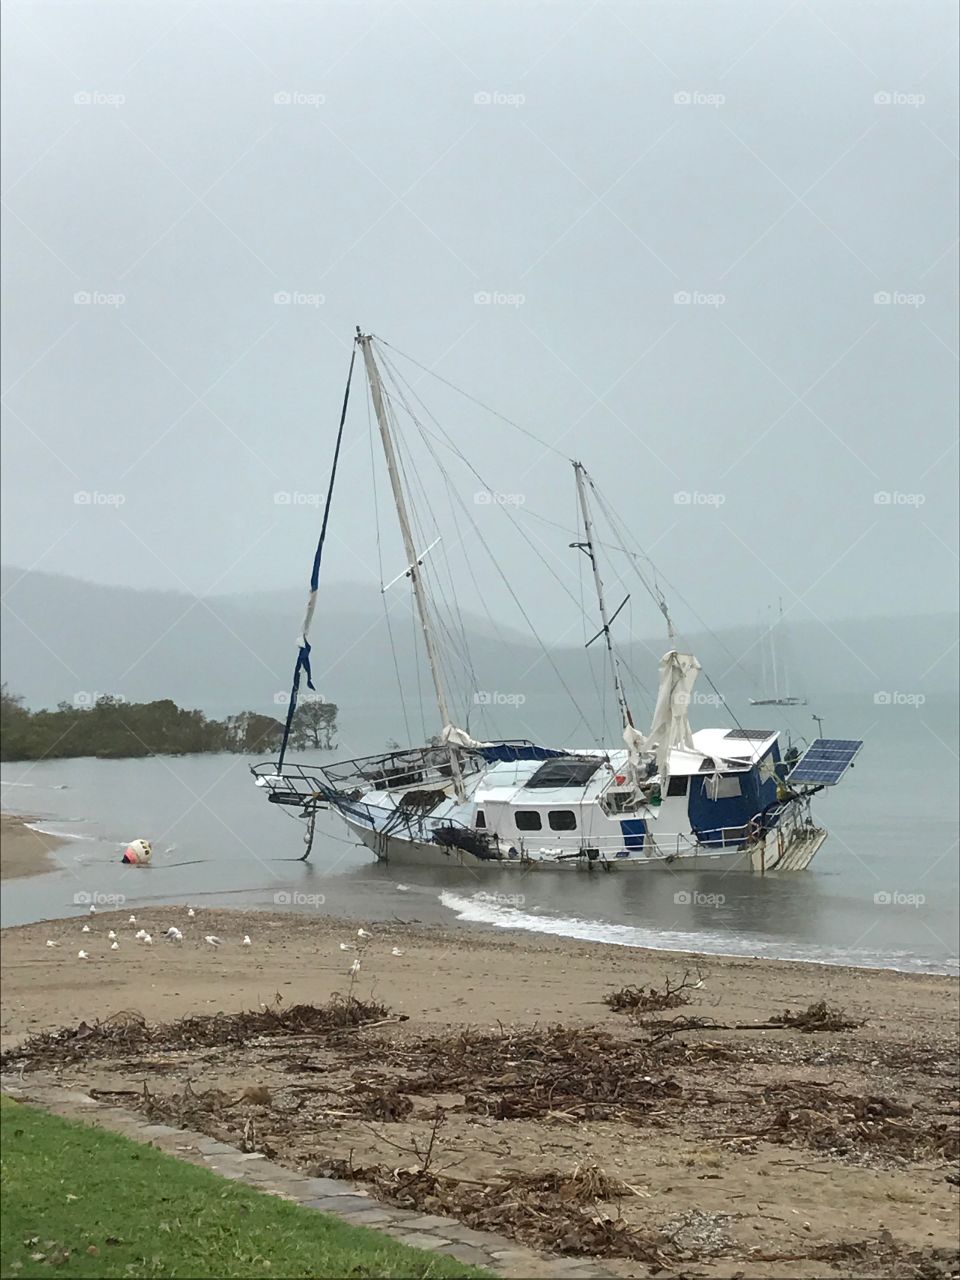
[[0, 685, 337, 760]]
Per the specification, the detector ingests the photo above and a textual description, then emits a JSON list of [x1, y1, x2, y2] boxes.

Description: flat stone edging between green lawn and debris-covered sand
[[0, 1076, 609, 1280]]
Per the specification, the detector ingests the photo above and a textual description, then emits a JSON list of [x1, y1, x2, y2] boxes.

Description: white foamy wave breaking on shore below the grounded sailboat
[[439, 891, 960, 974]]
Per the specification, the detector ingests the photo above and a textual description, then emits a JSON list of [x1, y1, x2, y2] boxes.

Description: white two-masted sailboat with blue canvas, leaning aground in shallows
[[252, 330, 863, 872]]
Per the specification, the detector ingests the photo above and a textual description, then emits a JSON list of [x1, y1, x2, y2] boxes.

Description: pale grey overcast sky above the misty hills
[[3, 0, 957, 632]]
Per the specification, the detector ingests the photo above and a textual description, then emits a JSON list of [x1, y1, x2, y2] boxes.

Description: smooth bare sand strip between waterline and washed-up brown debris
[[3, 906, 960, 1039]]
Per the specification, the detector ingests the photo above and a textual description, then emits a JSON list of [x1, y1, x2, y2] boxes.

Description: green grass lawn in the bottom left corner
[[0, 1097, 489, 1280]]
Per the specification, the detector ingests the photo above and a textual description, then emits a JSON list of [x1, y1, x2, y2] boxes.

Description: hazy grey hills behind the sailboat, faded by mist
[[0, 568, 957, 736]]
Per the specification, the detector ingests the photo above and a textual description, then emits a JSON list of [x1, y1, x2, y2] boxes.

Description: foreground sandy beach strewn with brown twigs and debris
[[3, 906, 957, 1277]]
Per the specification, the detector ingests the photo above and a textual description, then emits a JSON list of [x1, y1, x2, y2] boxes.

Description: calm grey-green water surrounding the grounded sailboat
[[0, 698, 960, 973]]
